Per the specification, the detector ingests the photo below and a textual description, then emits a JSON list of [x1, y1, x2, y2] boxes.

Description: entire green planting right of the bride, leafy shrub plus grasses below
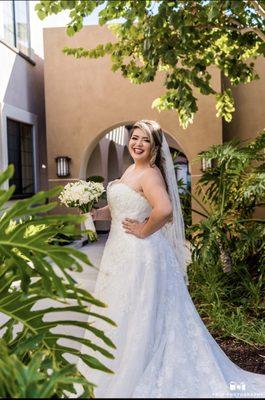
[[189, 131, 265, 345]]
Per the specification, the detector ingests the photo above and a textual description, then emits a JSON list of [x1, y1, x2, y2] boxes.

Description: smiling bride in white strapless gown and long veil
[[78, 120, 265, 398]]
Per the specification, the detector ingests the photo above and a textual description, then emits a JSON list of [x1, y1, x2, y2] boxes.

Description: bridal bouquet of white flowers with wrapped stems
[[58, 180, 105, 238]]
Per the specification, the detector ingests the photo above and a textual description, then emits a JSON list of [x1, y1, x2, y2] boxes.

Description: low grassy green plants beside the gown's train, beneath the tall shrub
[[189, 262, 265, 346]]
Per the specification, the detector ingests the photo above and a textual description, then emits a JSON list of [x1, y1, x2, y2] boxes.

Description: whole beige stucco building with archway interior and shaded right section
[[44, 26, 265, 222]]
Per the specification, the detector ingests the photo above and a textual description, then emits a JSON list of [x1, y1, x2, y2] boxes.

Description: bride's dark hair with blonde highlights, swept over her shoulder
[[130, 119, 168, 191]]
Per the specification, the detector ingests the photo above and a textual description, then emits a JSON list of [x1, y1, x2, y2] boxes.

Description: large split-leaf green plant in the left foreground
[[0, 166, 115, 397]]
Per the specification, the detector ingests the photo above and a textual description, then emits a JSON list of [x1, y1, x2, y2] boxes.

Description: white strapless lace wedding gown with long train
[[78, 180, 265, 398]]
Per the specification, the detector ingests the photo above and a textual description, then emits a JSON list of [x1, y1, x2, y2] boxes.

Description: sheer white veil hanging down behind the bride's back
[[158, 133, 189, 285]]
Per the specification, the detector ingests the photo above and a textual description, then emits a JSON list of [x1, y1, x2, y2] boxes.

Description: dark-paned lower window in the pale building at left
[[7, 118, 34, 197]]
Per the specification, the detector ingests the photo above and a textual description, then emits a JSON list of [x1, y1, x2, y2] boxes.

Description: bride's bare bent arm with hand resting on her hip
[[123, 169, 173, 238]]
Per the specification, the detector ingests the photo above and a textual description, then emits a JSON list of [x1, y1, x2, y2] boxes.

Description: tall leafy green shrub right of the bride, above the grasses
[[191, 131, 265, 272]]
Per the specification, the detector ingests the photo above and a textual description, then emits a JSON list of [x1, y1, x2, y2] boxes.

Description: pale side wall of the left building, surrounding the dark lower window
[[0, 42, 47, 190]]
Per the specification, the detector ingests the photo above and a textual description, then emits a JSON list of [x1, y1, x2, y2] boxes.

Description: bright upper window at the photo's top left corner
[[2, 0, 30, 57]]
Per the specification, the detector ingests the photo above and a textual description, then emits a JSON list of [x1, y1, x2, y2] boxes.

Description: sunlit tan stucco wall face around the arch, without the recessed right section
[[44, 26, 222, 222]]
